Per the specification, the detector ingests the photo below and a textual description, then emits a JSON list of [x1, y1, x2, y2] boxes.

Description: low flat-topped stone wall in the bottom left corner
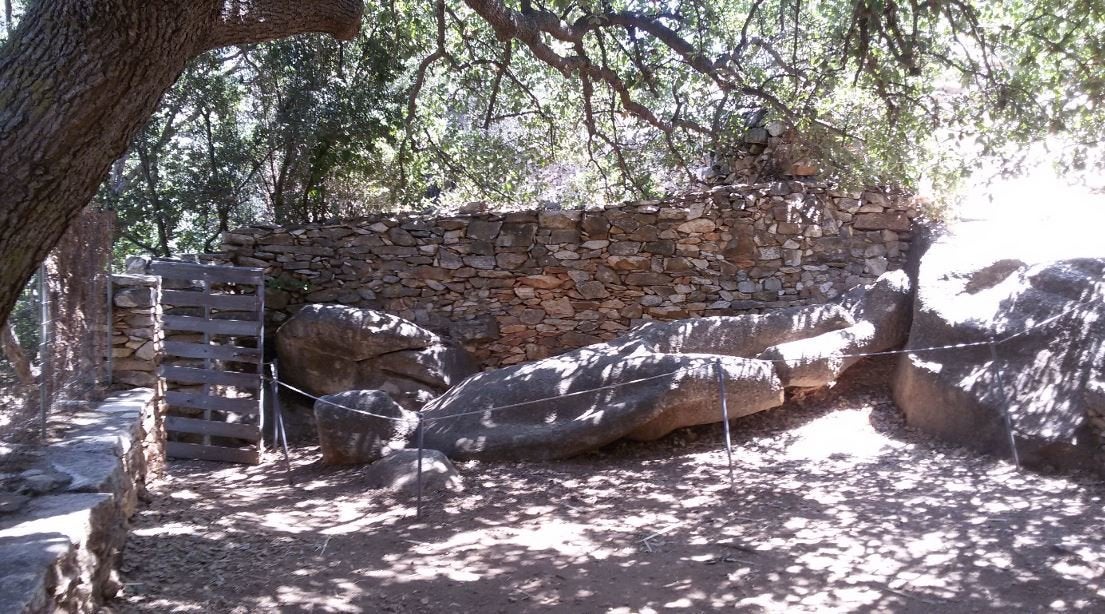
[[0, 389, 164, 613]]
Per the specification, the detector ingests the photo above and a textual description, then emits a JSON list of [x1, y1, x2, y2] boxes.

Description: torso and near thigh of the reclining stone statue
[[422, 343, 782, 459]]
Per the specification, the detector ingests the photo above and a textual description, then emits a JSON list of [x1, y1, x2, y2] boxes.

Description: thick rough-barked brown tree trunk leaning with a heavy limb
[[0, 0, 362, 319]]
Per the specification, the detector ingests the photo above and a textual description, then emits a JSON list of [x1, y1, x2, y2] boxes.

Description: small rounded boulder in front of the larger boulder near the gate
[[315, 390, 418, 465]]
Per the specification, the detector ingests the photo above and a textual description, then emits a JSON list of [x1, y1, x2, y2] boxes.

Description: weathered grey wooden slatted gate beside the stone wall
[[149, 261, 265, 464]]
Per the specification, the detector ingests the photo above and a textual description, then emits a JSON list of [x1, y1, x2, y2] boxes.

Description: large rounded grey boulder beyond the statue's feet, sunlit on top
[[894, 215, 1105, 467]]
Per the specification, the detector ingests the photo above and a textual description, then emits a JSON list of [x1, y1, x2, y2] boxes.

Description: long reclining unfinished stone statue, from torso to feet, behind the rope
[[422, 272, 909, 459]]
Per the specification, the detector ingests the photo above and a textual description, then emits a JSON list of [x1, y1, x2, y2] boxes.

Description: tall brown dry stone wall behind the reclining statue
[[215, 180, 915, 366]]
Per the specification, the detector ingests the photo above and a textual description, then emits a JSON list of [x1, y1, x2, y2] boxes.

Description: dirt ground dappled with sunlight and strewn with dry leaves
[[111, 359, 1105, 613]]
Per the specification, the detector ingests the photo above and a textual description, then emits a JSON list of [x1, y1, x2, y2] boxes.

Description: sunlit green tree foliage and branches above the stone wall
[[6, 0, 1105, 268]]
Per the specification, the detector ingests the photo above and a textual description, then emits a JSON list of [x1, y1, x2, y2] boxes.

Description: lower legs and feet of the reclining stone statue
[[758, 271, 913, 388]]
